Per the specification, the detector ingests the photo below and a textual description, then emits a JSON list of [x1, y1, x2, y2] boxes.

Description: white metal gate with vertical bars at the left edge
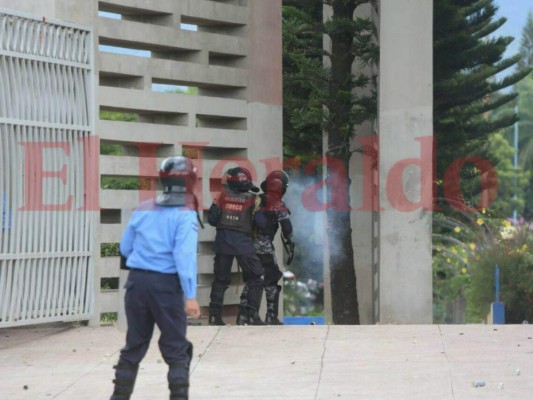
[[0, 9, 94, 327]]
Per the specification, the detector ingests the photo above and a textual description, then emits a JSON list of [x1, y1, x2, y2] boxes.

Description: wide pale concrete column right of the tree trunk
[[379, 0, 433, 324]]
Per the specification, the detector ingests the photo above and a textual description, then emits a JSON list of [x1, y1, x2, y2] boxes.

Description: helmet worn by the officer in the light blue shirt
[[159, 156, 196, 193]]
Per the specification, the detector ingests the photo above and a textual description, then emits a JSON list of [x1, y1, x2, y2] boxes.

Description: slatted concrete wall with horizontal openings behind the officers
[[0, 0, 282, 324]]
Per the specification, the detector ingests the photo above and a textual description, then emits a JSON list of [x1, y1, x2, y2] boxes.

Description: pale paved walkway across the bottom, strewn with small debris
[[0, 325, 533, 400]]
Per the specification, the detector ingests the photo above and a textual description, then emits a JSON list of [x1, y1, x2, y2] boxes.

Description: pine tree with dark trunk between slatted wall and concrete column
[[284, 0, 379, 324]]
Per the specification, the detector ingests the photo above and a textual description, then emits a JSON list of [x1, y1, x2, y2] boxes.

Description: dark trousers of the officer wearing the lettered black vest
[[211, 252, 264, 309]]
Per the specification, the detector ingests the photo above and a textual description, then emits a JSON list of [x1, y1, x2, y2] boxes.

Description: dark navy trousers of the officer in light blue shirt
[[120, 269, 192, 364]]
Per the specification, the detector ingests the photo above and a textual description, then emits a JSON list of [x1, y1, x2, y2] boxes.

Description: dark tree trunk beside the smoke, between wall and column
[[327, 0, 359, 325]]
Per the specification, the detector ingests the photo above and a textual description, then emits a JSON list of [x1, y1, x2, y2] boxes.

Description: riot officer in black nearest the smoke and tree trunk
[[237, 171, 294, 325]]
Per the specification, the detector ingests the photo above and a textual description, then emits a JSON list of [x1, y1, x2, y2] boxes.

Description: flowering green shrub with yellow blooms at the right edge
[[433, 212, 533, 323]]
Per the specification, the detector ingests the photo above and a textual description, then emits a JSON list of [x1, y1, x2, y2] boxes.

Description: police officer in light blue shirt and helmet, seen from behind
[[111, 157, 200, 400]]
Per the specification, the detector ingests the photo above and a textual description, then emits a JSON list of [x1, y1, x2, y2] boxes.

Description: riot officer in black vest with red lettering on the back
[[207, 167, 263, 325]]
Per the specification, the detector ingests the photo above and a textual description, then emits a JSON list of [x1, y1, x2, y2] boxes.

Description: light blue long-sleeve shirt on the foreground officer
[[120, 200, 198, 299]]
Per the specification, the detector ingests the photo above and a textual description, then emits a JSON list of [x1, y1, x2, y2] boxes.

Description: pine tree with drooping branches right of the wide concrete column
[[433, 0, 531, 209]]
